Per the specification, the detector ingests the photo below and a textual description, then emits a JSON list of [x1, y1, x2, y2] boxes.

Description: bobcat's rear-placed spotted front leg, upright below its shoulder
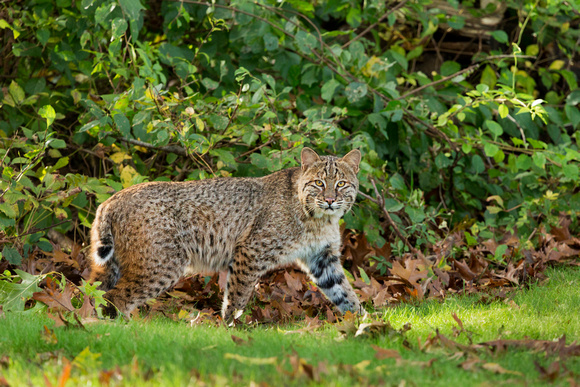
[[222, 247, 265, 325]]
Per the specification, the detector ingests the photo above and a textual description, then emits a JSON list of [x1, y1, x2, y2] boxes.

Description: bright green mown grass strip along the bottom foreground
[[0, 268, 580, 386]]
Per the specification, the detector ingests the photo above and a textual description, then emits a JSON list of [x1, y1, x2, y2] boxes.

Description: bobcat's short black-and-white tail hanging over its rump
[[91, 206, 121, 291]]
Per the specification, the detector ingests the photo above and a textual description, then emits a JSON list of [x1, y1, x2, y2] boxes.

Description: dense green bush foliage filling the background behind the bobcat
[[0, 0, 580, 265]]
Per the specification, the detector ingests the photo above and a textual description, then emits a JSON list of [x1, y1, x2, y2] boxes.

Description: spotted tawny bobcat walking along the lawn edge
[[90, 148, 364, 322]]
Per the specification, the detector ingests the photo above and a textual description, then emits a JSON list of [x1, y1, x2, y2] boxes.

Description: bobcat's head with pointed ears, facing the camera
[[298, 148, 361, 218]]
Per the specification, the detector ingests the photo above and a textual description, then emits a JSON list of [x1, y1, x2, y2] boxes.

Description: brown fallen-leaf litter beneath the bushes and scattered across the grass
[[0, 214, 580, 385]]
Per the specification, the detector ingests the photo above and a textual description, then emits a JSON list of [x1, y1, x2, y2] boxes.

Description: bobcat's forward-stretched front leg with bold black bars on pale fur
[[305, 247, 365, 314]]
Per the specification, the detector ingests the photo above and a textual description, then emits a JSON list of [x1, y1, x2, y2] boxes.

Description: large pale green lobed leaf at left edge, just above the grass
[[0, 269, 45, 312]]
